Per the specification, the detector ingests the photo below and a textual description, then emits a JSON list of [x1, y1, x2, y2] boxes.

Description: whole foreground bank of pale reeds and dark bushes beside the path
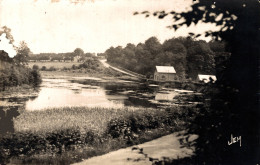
[[0, 107, 196, 164]]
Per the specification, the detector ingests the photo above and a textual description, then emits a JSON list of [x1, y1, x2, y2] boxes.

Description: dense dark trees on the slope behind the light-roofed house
[[105, 37, 229, 79]]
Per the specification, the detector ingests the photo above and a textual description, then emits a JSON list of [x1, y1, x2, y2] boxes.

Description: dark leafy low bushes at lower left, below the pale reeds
[[0, 129, 95, 163]]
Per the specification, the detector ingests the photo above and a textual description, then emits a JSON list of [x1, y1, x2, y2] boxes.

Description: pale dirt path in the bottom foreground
[[75, 133, 197, 165]]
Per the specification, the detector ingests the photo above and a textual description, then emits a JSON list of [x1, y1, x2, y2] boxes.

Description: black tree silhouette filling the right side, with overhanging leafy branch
[[135, 0, 260, 164]]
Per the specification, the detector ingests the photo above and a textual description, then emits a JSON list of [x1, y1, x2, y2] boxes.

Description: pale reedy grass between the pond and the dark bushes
[[14, 107, 150, 134]]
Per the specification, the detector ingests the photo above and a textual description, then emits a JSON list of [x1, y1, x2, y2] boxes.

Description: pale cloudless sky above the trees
[[0, 0, 218, 53]]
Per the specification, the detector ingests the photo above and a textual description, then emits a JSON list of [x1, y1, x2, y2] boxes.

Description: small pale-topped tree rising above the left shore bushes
[[14, 41, 32, 65]]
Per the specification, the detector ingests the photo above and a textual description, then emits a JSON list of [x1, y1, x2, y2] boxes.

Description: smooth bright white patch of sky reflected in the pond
[[26, 87, 126, 110]]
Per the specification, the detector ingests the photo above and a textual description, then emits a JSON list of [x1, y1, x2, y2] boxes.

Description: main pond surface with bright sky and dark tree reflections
[[25, 77, 199, 110]]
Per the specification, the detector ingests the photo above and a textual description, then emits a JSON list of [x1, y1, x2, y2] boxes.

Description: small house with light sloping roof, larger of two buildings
[[154, 66, 178, 81]]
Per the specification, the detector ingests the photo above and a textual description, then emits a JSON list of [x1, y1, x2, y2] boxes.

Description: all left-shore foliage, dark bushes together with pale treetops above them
[[0, 26, 41, 91]]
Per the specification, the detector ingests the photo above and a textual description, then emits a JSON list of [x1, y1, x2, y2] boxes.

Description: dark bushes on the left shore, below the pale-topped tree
[[0, 51, 41, 91]]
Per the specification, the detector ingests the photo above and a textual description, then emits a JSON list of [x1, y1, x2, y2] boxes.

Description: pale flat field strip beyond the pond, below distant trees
[[28, 62, 82, 69]]
